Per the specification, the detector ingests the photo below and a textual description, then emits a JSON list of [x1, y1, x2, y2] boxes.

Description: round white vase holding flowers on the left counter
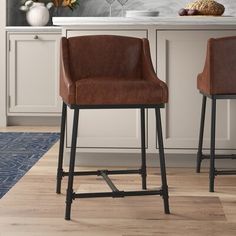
[[26, 2, 49, 26]]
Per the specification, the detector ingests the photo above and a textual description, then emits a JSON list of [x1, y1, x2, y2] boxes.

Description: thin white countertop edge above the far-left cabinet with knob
[[5, 26, 62, 33]]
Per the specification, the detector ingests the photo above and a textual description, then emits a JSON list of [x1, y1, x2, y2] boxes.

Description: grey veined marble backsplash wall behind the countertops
[[6, 0, 236, 25]]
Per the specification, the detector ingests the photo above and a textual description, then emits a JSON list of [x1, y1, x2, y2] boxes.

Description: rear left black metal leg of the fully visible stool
[[56, 102, 67, 193]]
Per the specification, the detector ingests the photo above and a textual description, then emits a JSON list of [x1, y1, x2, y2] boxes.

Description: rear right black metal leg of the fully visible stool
[[141, 108, 147, 189]]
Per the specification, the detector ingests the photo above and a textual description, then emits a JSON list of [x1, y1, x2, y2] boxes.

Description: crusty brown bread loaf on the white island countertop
[[186, 0, 225, 16]]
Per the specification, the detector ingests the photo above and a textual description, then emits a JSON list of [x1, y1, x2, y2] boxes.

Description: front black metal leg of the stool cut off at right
[[209, 97, 216, 192]]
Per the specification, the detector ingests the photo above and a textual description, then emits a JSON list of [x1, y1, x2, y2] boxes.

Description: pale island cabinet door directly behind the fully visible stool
[[67, 30, 147, 148]]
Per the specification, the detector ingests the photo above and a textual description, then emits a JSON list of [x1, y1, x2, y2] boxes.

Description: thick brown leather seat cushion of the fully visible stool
[[75, 78, 168, 105]]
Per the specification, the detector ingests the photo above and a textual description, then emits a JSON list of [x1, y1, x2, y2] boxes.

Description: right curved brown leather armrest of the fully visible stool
[[142, 39, 168, 102]]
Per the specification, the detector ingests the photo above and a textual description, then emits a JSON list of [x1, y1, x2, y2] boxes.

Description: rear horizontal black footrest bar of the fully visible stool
[[62, 169, 142, 176]]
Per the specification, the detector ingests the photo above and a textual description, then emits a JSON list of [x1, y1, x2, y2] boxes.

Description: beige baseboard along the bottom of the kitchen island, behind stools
[[62, 153, 236, 168]]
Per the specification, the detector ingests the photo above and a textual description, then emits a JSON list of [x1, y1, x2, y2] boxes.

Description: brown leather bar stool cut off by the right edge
[[196, 37, 236, 192]]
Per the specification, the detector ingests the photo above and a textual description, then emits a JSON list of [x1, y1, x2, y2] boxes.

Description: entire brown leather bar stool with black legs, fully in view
[[56, 35, 170, 220]]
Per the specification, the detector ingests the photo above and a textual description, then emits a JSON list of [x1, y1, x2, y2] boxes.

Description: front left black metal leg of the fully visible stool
[[65, 109, 79, 220]]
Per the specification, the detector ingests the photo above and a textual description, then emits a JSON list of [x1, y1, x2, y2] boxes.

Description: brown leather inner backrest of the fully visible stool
[[62, 35, 142, 81]]
